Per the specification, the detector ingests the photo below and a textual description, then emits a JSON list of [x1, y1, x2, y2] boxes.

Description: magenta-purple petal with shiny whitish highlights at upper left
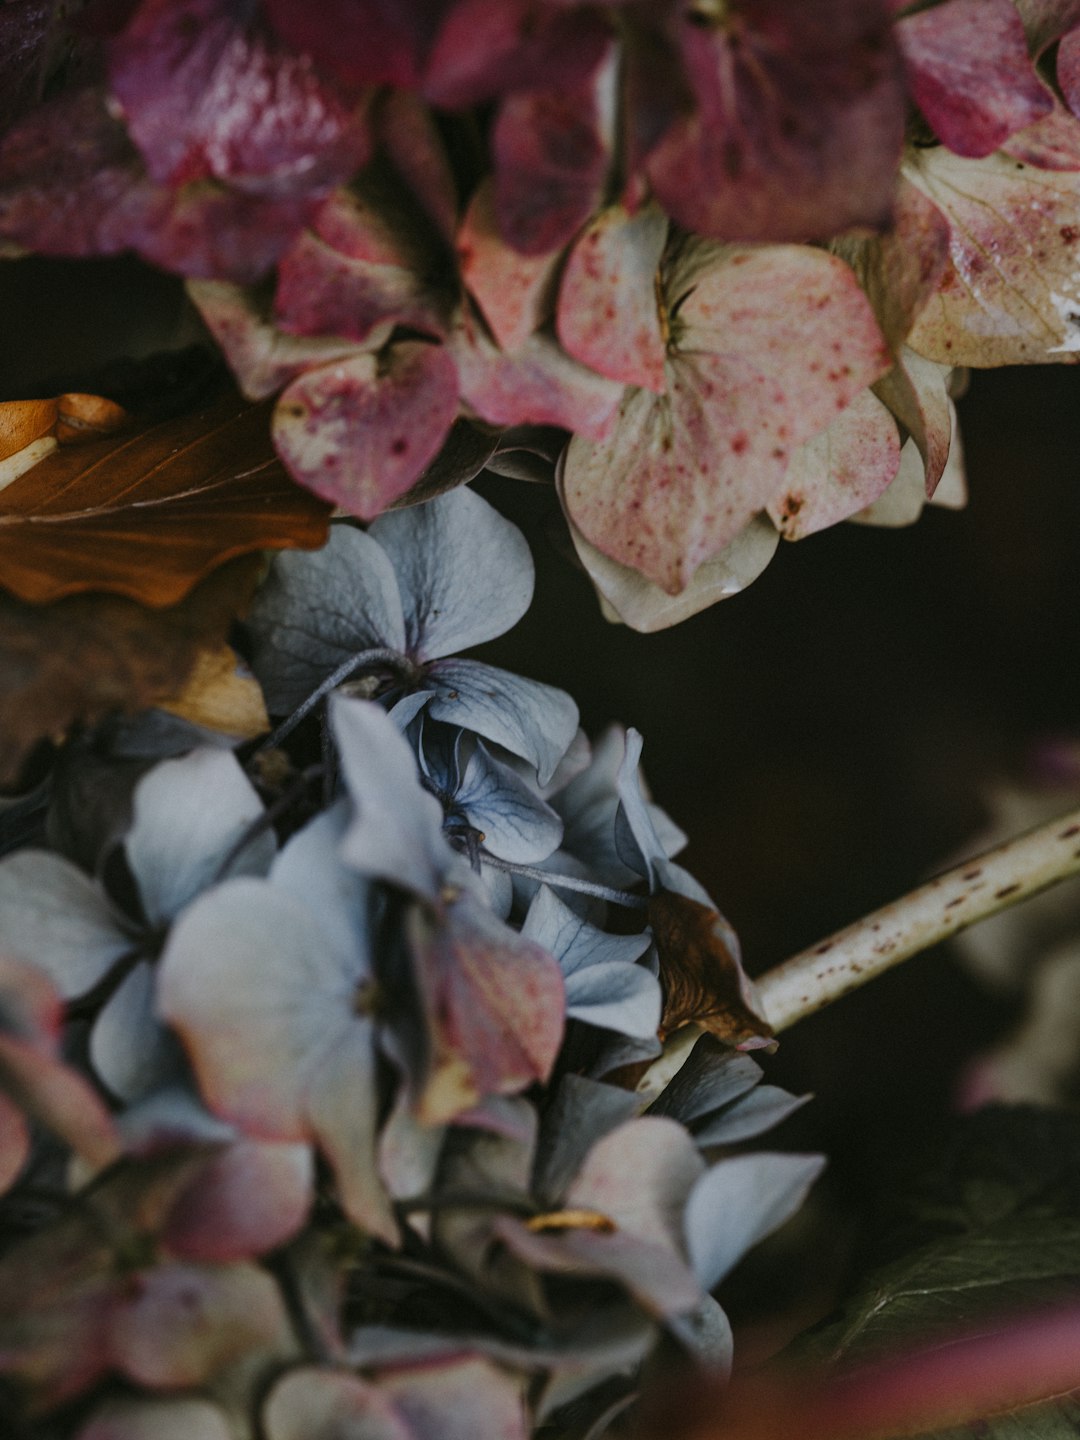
[[109, 0, 367, 193]]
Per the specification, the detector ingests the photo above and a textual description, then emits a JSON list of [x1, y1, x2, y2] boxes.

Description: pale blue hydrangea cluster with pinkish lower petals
[[0, 488, 821, 1440]]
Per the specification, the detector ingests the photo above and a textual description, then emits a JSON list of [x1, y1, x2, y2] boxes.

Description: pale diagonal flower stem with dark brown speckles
[[756, 808, 1080, 1030]]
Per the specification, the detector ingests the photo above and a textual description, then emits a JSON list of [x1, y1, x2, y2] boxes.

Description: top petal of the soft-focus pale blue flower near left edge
[[124, 749, 276, 924]]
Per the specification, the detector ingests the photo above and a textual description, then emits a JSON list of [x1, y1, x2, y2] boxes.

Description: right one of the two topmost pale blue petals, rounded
[[370, 485, 533, 661]]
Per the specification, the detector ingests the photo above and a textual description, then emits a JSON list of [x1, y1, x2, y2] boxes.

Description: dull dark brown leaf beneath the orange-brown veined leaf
[[0, 556, 262, 785]]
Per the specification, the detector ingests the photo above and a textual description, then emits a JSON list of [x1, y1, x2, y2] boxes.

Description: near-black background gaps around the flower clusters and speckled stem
[[0, 259, 1080, 1347]]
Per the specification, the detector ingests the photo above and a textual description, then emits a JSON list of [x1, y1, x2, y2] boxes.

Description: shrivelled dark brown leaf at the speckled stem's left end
[[648, 890, 773, 1050]]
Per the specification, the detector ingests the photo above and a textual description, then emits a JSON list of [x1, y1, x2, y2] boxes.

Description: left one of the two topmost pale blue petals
[[246, 526, 405, 716]]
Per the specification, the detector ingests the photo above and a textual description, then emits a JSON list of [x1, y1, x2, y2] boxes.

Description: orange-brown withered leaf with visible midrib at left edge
[[0, 396, 330, 606]]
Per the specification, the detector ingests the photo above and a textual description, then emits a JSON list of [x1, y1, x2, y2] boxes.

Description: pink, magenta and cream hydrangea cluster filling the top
[[0, 0, 1080, 629]]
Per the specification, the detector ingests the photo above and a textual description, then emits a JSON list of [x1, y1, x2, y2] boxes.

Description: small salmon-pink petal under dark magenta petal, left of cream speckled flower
[[456, 177, 561, 351]]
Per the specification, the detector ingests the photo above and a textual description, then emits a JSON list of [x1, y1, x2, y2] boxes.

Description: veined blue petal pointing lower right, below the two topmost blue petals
[[423, 660, 577, 785]]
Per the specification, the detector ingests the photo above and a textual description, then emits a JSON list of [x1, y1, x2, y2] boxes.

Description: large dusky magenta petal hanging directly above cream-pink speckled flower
[[645, 0, 904, 240]]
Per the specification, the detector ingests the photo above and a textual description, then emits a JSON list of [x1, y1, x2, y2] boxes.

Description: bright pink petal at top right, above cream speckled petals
[[897, 0, 1060, 156]]
